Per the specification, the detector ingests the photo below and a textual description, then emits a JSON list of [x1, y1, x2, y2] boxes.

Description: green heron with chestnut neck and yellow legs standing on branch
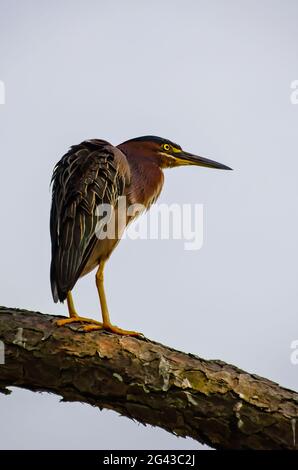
[[50, 135, 231, 336]]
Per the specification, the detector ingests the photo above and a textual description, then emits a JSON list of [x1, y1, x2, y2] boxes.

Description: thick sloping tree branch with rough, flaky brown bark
[[0, 307, 298, 449]]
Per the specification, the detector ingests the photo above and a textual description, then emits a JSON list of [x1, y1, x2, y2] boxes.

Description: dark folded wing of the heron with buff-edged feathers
[[50, 140, 130, 302]]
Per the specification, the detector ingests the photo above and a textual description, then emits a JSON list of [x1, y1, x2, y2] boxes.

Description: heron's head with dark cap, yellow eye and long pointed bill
[[119, 135, 232, 170]]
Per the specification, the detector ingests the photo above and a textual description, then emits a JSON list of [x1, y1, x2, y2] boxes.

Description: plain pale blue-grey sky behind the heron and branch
[[0, 0, 298, 449]]
